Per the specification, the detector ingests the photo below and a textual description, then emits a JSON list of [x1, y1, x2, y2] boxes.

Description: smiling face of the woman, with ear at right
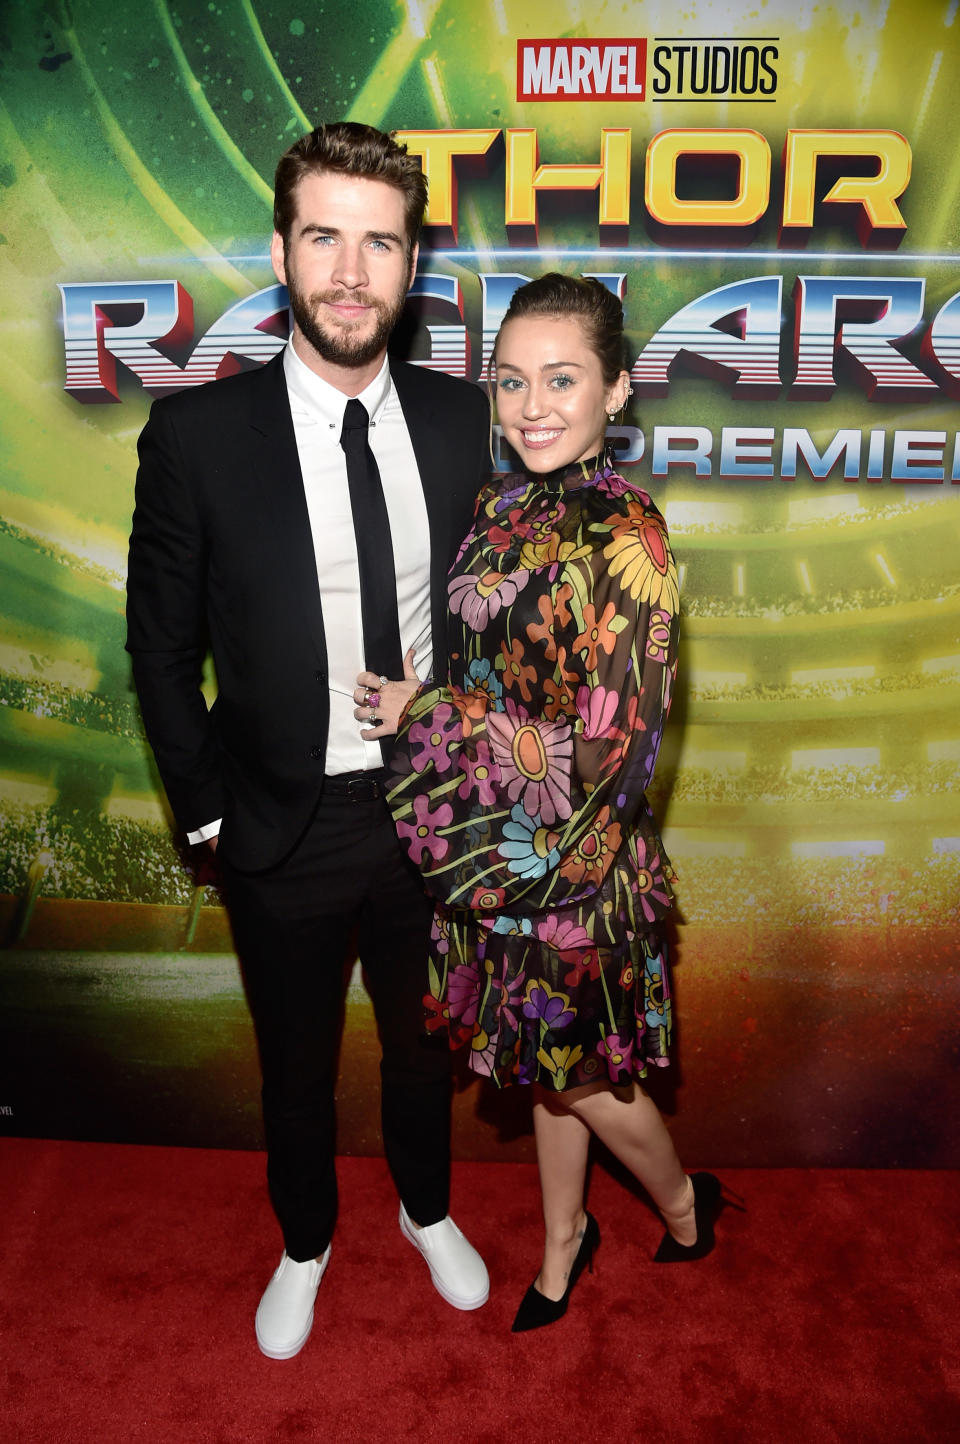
[[495, 316, 629, 472]]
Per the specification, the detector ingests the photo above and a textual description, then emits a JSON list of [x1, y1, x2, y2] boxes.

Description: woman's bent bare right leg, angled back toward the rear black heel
[[564, 1083, 697, 1245]]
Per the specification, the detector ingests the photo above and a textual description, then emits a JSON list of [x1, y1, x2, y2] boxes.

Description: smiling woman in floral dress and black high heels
[[355, 274, 730, 1331]]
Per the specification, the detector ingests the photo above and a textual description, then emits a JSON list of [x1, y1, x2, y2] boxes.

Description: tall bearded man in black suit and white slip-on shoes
[[127, 123, 489, 1359]]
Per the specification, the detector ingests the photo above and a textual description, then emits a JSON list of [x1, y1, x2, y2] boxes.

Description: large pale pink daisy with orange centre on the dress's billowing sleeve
[[486, 702, 573, 826]]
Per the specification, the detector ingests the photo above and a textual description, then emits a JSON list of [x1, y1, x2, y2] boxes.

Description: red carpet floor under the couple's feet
[[0, 1139, 960, 1444]]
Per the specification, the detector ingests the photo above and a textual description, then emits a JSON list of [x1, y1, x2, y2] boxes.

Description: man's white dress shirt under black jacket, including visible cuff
[[188, 341, 433, 842]]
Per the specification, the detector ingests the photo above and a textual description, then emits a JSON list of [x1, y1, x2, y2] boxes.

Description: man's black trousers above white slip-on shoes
[[222, 778, 450, 1262]]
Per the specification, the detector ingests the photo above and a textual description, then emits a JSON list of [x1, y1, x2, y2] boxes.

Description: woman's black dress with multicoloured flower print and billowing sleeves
[[388, 458, 678, 1089]]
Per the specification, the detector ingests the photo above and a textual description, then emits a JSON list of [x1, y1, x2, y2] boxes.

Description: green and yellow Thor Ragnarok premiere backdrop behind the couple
[[0, 0, 960, 1167]]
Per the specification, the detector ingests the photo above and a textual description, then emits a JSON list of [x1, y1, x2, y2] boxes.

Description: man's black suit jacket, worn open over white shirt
[[127, 354, 489, 871]]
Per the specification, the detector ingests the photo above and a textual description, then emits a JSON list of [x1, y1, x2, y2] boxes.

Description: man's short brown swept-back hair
[[273, 120, 427, 251]]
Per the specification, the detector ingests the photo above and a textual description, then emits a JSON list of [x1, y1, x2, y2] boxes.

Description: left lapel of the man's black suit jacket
[[250, 351, 326, 658]]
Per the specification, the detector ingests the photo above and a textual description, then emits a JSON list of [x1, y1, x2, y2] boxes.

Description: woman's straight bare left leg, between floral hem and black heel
[[533, 1083, 590, 1298]]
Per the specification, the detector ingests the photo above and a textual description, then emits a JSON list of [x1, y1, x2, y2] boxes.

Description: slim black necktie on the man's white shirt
[[341, 400, 403, 679]]
